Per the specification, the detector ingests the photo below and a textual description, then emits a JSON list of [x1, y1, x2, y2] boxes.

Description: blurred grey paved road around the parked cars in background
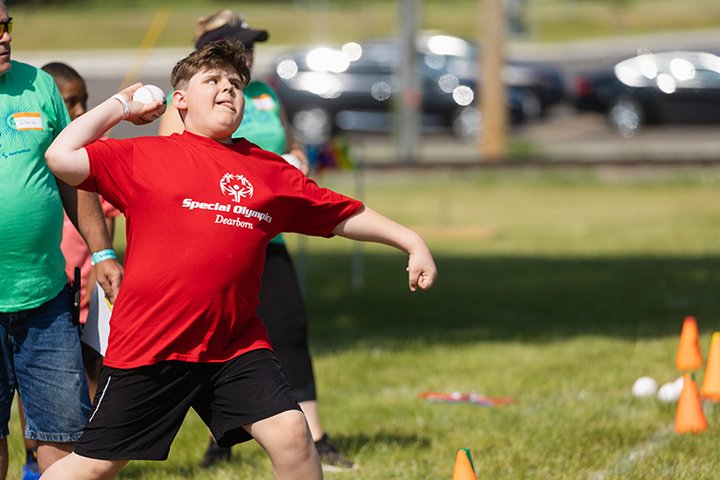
[[13, 30, 720, 164]]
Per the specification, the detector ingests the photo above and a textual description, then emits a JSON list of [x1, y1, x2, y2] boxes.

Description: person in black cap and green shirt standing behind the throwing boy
[[159, 10, 357, 471]]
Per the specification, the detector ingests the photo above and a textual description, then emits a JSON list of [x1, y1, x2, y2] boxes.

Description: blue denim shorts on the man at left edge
[[0, 288, 90, 443]]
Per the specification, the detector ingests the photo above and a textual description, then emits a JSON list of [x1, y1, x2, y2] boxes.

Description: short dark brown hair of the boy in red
[[170, 40, 250, 88]]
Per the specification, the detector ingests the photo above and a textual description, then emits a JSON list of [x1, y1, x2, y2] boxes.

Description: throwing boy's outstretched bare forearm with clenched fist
[[333, 207, 437, 292]]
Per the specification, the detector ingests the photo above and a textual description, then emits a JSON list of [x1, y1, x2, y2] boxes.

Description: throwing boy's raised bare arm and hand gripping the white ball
[[45, 83, 165, 186]]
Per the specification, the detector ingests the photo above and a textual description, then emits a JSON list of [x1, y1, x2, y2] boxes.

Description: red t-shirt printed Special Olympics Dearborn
[[80, 132, 362, 368]]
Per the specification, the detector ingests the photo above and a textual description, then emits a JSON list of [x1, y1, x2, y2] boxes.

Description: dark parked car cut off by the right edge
[[573, 51, 720, 137]]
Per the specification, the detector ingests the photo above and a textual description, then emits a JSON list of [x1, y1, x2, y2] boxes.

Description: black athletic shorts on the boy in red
[[75, 350, 300, 460]]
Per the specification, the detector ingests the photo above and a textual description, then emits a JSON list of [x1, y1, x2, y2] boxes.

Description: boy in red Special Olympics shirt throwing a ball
[[43, 42, 437, 480]]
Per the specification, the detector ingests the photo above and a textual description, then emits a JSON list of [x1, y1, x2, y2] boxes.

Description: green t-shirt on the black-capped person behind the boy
[[233, 80, 287, 243]]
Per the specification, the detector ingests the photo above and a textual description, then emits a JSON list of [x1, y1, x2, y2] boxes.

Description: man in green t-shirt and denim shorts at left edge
[[0, 0, 122, 480]]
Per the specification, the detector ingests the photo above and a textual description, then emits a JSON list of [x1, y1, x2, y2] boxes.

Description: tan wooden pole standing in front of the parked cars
[[478, 0, 508, 161]]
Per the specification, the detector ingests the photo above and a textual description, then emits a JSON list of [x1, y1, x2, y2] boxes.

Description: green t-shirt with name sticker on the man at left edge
[[0, 61, 70, 312]]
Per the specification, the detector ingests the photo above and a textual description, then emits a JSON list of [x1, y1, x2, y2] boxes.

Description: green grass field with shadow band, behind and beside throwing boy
[[10, 169, 720, 480]]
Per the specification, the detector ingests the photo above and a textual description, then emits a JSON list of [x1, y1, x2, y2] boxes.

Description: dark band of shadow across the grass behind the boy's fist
[[304, 254, 720, 352]]
